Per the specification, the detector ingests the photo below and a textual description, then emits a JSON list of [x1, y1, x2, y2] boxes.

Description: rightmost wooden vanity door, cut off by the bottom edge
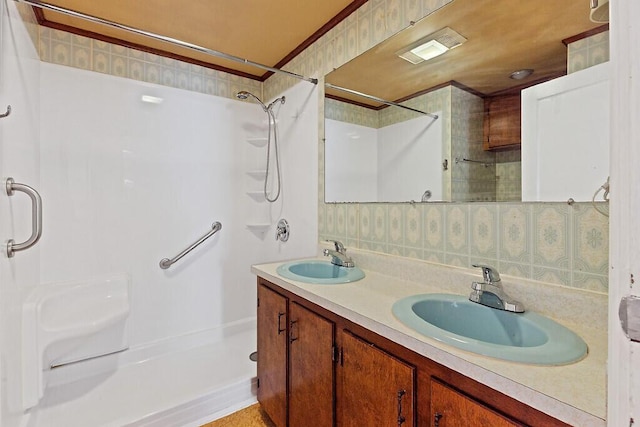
[[431, 379, 523, 427]]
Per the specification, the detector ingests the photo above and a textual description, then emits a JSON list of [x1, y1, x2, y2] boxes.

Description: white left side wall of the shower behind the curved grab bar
[[0, 1, 40, 427]]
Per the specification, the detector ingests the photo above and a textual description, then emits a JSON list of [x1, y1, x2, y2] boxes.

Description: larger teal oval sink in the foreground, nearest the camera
[[392, 294, 587, 365]]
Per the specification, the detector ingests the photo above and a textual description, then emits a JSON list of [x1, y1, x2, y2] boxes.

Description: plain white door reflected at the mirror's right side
[[522, 63, 611, 202]]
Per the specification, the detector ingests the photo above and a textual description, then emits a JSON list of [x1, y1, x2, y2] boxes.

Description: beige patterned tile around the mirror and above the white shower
[[21, 0, 609, 292]]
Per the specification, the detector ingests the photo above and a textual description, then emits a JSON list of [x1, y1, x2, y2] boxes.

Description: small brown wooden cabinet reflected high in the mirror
[[482, 93, 521, 150]]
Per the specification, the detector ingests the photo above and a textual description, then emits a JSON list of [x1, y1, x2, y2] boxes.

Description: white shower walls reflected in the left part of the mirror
[[325, 106, 443, 202]]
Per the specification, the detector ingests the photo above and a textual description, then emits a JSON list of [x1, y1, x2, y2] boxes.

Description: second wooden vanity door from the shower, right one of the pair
[[289, 303, 334, 427]]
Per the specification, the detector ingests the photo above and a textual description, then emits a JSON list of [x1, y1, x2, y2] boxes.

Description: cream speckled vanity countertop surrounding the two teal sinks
[[251, 252, 607, 427]]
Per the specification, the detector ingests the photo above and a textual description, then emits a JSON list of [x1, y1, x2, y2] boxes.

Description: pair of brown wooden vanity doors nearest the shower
[[257, 279, 337, 427]]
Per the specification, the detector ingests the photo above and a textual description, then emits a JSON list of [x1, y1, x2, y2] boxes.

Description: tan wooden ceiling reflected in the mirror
[[325, 0, 608, 105]]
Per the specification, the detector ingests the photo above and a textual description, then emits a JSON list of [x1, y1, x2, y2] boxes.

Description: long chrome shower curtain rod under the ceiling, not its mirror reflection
[[14, 0, 318, 84]]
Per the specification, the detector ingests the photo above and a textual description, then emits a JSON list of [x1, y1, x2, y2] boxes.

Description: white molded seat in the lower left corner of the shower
[[22, 275, 131, 409]]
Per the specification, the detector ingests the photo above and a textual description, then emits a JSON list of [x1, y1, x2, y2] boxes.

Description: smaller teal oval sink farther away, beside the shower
[[276, 260, 364, 285]]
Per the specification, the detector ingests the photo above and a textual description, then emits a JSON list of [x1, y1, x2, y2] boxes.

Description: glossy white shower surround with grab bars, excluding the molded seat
[[0, 1, 318, 427]]
